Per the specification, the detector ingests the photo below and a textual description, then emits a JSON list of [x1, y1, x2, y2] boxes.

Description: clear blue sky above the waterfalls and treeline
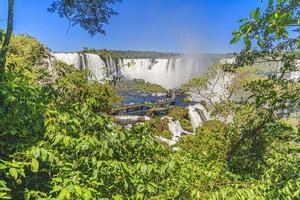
[[0, 0, 260, 53]]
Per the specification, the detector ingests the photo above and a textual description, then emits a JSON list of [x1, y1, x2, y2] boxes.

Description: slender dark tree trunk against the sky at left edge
[[0, 0, 14, 76]]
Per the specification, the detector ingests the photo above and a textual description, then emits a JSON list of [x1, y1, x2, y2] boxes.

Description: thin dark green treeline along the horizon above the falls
[[80, 47, 233, 59]]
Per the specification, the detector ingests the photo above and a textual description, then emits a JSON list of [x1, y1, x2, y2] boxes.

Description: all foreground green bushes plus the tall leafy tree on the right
[[0, 0, 300, 200]]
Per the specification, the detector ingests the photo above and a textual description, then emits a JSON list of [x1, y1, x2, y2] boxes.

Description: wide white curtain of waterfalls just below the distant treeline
[[53, 53, 212, 89]]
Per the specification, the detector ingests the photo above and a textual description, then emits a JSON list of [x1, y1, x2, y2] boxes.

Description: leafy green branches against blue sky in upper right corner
[[231, 0, 300, 51]]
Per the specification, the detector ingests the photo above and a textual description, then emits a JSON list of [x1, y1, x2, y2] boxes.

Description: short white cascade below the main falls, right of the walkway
[[188, 104, 210, 130]]
